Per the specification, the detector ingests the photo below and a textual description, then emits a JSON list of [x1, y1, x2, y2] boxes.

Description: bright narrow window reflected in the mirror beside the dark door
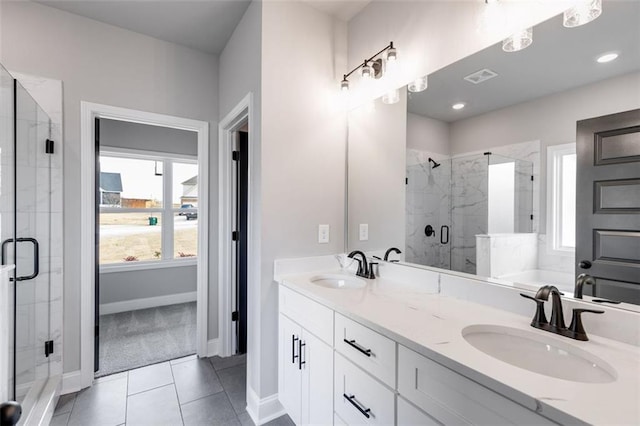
[[547, 143, 576, 252]]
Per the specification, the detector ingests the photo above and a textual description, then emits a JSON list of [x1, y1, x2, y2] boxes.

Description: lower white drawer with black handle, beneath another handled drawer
[[333, 353, 395, 425]]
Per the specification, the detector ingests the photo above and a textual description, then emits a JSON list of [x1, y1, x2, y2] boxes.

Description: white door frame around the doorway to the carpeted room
[[80, 101, 209, 387]]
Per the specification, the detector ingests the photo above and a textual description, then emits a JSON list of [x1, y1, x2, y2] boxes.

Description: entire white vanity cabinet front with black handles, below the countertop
[[279, 286, 555, 426]]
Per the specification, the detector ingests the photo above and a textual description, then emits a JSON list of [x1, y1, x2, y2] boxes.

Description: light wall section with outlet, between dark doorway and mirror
[[256, 2, 346, 397]]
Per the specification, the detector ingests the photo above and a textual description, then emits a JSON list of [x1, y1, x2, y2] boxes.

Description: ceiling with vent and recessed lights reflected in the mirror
[[408, 1, 640, 122]]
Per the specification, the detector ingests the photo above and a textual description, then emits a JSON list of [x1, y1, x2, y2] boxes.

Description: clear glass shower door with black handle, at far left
[[11, 80, 51, 402]]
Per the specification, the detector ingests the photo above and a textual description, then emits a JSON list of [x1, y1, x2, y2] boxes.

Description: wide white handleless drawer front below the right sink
[[398, 345, 555, 425]]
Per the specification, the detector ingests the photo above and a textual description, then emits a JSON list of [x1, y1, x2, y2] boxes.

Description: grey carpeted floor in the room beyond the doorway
[[95, 302, 196, 377]]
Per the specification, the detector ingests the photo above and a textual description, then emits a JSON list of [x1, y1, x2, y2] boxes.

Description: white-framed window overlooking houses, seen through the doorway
[[97, 150, 198, 269]]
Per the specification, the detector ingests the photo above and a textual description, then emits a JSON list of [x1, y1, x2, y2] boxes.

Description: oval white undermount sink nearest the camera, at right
[[462, 325, 617, 383]]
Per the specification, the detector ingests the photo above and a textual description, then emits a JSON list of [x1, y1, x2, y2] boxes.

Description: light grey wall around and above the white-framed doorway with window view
[[0, 2, 218, 372]]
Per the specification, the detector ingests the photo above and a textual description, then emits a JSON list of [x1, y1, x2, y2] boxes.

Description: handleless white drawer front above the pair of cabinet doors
[[279, 285, 333, 346]]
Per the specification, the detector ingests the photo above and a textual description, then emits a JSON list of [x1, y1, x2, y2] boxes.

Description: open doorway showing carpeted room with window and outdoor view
[[94, 118, 199, 377]]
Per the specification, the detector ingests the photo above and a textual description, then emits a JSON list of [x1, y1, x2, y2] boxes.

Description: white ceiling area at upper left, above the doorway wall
[[36, 0, 251, 55]]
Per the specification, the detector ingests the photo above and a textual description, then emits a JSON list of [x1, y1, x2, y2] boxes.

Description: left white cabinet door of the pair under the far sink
[[278, 315, 302, 425]]
